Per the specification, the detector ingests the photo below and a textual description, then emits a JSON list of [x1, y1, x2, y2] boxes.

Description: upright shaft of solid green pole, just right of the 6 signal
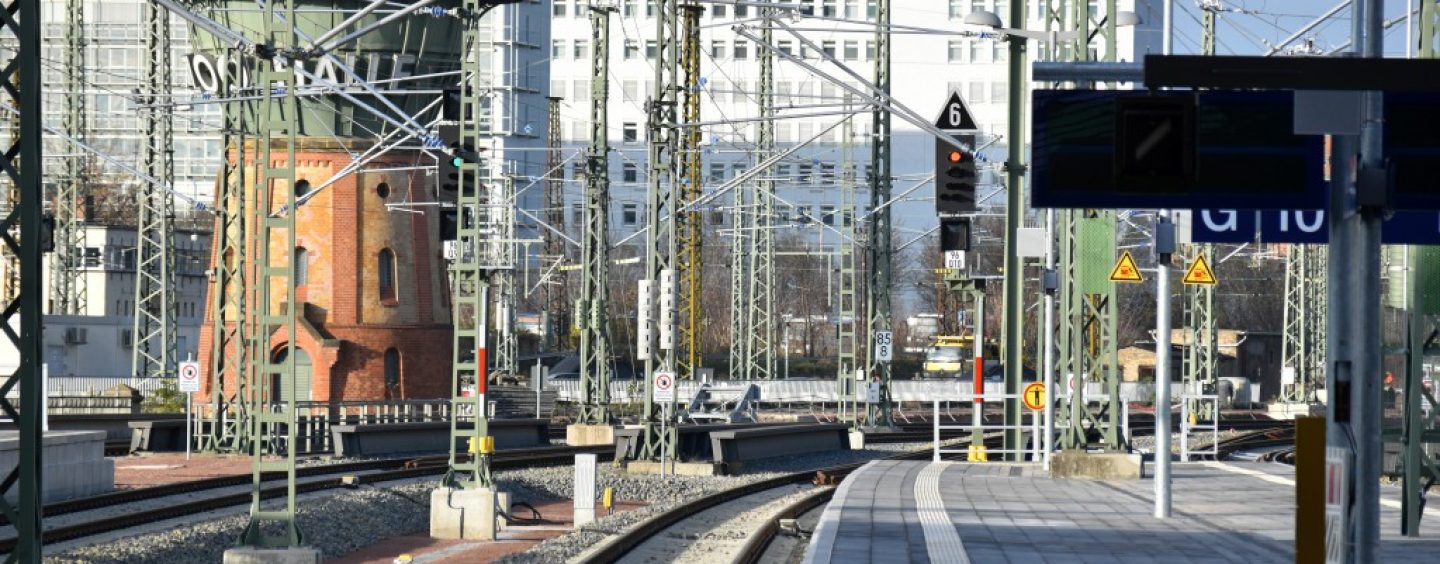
[[1002, 1, 1028, 460]]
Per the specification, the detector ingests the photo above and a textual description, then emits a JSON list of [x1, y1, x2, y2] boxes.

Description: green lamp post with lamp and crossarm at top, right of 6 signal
[[963, 6, 1140, 460]]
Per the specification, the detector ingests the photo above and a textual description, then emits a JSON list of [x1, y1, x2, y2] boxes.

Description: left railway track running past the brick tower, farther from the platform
[[0, 446, 613, 554]]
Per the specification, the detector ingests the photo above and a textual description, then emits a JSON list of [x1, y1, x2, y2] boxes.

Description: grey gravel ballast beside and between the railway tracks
[[46, 443, 929, 564]]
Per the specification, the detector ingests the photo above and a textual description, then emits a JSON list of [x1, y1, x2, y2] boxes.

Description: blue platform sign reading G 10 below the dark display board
[[1191, 210, 1440, 245]]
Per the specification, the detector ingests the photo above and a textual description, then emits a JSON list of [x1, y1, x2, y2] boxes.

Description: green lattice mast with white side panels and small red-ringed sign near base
[[638, 0, 681, 459]]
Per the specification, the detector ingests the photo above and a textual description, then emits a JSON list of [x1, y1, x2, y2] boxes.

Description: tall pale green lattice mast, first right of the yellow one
[[744, 7, 775, 380]]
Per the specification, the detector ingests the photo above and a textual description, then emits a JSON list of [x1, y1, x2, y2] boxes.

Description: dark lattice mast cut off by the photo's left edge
[[0, 0, 45, 564]]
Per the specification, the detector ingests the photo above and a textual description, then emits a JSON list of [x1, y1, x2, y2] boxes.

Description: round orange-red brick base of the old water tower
[[200, 143, 451, 401]]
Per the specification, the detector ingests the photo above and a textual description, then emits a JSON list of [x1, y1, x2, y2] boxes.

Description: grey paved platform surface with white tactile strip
[[805, 460, 1440, 564]]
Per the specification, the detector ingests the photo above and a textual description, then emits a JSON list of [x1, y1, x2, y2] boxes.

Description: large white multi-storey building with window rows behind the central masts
[[550, 0, 1161, 251]]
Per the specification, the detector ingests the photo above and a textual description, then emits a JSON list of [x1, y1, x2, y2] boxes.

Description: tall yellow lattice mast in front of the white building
[[675, 4, 704, 378]]
